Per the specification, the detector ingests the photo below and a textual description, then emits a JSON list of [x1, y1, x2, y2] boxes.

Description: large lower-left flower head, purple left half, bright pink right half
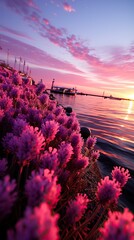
[[25, 169, 61, 207]]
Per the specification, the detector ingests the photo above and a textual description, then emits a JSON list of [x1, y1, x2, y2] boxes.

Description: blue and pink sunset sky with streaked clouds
[[0, 0, 134, 99]]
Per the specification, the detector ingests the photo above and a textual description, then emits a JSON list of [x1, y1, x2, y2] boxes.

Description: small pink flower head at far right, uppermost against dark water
[[112, 167, 131, 187]]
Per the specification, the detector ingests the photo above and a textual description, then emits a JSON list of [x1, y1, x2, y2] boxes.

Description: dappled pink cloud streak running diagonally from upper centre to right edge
[[41, 20, 134, 84]]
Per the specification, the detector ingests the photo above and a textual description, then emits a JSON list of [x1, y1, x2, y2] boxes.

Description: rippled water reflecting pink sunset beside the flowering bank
[[52, 94, 134, 211]]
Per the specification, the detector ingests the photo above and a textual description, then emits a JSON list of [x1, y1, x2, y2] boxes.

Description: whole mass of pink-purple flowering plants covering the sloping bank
[[0, 64, 133, 240]]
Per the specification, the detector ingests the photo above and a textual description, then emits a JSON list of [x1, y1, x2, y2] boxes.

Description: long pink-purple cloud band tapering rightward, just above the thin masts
[[0, 35, 82, 75]]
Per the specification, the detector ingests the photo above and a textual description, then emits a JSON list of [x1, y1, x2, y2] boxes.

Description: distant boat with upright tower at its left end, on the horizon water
[[50, 80, 77, 96]]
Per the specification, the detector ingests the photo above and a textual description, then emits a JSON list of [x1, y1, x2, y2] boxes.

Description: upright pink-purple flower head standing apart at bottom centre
[[66, 194, 89, 224]]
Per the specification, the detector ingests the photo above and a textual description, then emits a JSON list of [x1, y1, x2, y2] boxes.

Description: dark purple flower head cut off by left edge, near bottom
[[0, 176, 17, 220]]
